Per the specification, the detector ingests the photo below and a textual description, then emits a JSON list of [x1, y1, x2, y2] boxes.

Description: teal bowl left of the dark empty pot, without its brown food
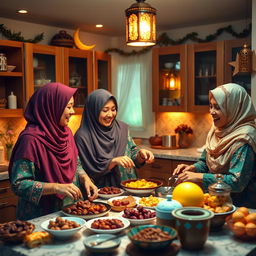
[[127, 225, 177, 250]]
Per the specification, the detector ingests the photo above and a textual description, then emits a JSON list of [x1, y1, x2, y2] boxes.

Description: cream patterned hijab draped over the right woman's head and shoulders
[[206, 83, 256, 173]]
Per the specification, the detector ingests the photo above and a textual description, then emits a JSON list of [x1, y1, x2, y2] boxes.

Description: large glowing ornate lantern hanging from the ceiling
[[125, 0, 156, 46]]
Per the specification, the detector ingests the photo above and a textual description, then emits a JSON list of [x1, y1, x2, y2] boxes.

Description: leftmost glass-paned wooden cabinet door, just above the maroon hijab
[[25, 43, 63, 100]]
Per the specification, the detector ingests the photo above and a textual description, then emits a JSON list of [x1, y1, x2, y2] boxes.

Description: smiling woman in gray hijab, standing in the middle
[[75, 89, 154, 187]]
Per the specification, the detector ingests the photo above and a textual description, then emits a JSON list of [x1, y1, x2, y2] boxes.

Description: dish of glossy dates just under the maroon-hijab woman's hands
[[62, 200, 111, 220]]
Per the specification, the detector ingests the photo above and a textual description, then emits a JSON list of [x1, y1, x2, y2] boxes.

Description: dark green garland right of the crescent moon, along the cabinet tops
[[105, 24, 252, 56]]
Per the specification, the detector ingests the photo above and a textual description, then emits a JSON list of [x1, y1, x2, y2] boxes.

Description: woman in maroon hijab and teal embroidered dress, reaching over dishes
[[9, 83, 97, 220]]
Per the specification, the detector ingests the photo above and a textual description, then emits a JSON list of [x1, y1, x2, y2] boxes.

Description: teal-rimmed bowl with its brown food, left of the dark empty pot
[[127, 225, 177, 250]]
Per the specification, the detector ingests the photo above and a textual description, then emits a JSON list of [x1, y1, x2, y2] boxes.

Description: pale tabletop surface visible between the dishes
[[0, 196, 256, 256]]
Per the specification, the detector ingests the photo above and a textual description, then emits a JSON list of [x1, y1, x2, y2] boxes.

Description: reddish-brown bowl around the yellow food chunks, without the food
[[121, 179, 163, 195]]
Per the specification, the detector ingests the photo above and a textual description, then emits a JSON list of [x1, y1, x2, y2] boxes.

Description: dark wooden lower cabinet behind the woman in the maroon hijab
[[0, 180, 17, 223]]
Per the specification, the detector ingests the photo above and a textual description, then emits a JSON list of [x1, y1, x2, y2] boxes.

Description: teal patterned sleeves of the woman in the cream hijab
[[203, 144, 256, 192]]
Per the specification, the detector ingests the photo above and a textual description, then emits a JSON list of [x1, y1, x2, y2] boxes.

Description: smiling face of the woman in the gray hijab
[[99, 100, 117, 127]]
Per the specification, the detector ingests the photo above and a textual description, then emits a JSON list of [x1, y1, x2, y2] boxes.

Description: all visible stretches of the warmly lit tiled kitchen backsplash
[[0, 112, 212, 150]]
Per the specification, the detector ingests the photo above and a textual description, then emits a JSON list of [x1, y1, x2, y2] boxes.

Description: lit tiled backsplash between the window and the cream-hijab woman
[[156, 112, 212, 147]]
